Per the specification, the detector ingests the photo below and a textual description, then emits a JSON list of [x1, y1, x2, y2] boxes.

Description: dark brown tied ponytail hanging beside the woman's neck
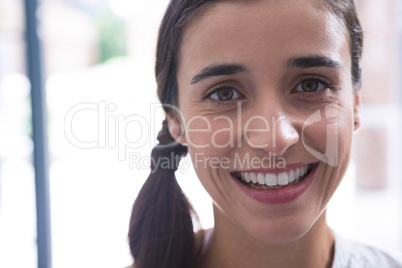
[[129, 119, 196, 268]]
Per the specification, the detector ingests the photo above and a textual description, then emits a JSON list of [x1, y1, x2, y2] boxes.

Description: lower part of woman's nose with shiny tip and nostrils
[[244, 112, 300, 156]]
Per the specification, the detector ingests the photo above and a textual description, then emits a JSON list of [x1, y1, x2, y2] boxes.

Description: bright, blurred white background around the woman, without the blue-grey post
[[0, 0, 402, 268]]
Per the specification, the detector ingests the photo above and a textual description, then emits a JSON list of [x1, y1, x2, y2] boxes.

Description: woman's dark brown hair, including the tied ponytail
[[129, 0, 363, 268]]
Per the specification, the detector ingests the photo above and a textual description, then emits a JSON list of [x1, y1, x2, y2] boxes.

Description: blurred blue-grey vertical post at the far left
[[24, 0, 52, 268]]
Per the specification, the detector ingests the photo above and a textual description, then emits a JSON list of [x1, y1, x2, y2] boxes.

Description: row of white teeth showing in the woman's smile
[[240, 165, 309, 189]]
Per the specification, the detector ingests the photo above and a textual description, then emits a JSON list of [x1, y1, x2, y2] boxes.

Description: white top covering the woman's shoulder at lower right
[[333, 233, 402, 268]]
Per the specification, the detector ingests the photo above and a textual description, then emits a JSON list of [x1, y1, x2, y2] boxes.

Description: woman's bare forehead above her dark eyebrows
[[179, 0, 350, 81]]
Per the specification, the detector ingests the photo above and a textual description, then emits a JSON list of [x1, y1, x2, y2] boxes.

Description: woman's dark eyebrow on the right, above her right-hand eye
[[286, 56, 343, 69]]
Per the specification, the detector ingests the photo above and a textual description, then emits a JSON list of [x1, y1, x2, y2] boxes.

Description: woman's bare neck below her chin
[[199, 207, 334, 268]]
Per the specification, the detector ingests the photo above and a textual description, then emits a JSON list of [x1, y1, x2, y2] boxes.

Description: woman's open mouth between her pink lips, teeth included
[[234, 164, 313, 189]]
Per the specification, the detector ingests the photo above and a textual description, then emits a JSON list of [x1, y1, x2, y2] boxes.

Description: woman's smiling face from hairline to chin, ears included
[[169, 0, 359, 243]]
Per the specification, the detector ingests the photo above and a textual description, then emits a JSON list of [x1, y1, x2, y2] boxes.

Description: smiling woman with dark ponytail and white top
[[129, 0, 402, 268]]
